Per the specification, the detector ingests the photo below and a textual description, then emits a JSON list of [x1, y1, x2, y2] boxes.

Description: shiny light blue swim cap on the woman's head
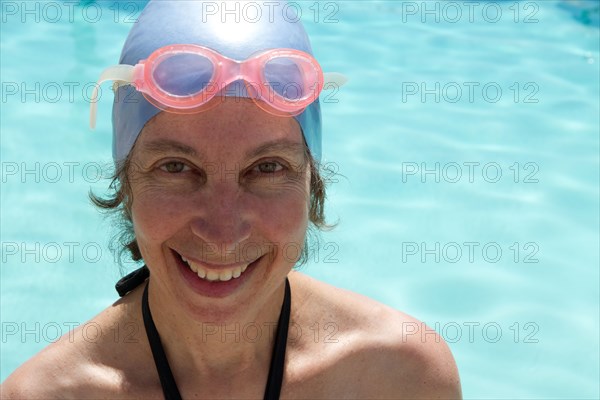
[[112, 0, 321, 164]]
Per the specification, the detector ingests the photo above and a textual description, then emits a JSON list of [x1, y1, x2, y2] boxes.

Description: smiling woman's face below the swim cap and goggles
[[129, 97, 310, 312]]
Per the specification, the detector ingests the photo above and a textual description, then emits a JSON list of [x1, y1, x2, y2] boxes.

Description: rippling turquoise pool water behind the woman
[[0, 1, 600, 399]]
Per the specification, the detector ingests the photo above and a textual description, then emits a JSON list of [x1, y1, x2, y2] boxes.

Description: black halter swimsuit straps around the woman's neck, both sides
[[116, 266, 291, 400]]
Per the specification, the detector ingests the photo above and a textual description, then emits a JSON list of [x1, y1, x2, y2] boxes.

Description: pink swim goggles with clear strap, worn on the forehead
[[90, 44, 346, 128]]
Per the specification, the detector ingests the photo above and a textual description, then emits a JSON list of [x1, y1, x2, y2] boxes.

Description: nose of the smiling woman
[[190, 182, 251, 252]]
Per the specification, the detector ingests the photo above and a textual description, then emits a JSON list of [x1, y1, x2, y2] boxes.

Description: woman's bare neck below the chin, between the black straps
[[148, 282, 285, 379]]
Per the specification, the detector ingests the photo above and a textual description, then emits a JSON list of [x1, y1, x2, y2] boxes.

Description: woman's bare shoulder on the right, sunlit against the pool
[[293, 273, 461, 399]]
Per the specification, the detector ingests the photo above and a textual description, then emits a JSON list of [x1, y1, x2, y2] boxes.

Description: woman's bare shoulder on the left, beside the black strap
[[2, 286, 156, 399]]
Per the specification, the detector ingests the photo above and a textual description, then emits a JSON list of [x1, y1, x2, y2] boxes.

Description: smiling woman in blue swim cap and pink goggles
[[2, 1, 461, 399]]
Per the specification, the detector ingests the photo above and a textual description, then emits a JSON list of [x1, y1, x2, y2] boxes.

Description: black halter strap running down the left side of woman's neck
[[142, 283, 181, 400]]
